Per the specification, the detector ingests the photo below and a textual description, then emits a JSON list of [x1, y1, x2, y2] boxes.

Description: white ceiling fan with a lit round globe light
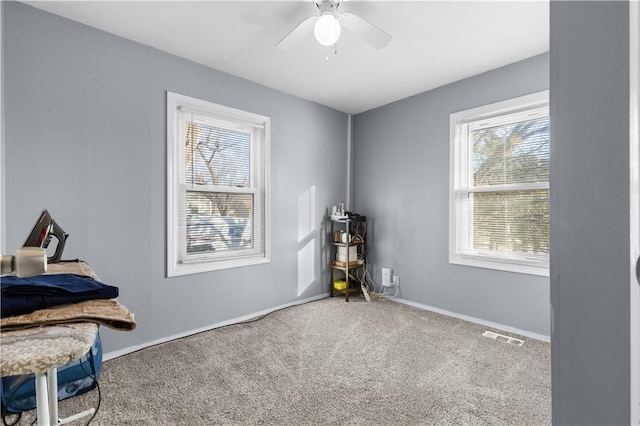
[[276, 0, 391, 49]]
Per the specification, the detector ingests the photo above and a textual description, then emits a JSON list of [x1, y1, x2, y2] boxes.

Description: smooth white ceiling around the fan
[[25, 0, 549, 114]]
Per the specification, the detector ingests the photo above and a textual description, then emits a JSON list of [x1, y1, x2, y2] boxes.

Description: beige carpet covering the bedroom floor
[[10, 297, 551, 425]]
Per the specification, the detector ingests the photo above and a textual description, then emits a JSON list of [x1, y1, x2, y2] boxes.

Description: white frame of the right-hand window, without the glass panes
[[449, 90, 549, 276]]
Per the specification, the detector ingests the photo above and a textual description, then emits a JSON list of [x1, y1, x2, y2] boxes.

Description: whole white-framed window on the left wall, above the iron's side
[[167, 92, 270, 277]]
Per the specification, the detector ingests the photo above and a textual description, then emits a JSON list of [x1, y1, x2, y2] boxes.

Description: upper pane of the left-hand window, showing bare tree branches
[[184, 119, 251, 188]]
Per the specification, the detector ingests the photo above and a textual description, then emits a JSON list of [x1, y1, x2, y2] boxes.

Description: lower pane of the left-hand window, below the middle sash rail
[[187, 191, 254, 254]]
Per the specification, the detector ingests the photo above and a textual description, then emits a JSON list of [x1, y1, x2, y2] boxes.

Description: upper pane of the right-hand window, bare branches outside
[[470, 117, 549, 186]]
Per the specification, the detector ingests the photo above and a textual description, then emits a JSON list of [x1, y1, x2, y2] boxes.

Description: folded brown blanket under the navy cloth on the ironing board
[[0, 299, 136, 331]]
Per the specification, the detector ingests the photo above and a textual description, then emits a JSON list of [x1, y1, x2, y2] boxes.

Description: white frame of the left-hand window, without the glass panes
[[167, 91, 271, 277]]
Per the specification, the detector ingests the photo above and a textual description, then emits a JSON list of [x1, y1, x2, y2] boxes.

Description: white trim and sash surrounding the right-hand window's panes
[[449, 90, 549, 277]]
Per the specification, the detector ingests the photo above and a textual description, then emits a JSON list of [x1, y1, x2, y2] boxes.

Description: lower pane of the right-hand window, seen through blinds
[[469, 189, 549, 254]]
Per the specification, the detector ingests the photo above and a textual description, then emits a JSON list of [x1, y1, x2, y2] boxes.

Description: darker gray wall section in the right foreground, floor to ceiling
[[550, 1, 635, 425]]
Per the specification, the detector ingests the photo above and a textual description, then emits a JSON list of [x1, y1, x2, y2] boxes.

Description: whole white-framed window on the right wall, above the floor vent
[[449, 92, 549, 275]]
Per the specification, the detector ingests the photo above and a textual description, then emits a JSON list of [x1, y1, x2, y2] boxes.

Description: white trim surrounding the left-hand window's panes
[[167, 91, 271, 277]]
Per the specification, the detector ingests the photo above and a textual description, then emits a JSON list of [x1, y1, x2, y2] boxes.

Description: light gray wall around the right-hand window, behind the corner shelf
[[353, 54, 550, 336]]
